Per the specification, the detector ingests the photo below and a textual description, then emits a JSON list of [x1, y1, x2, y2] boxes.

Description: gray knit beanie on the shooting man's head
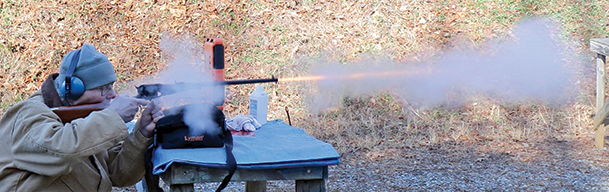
[[55, 44, 116, 97]]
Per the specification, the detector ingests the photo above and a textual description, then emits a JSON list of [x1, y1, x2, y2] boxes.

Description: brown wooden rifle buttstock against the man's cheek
[[51, 103, 108, 123]]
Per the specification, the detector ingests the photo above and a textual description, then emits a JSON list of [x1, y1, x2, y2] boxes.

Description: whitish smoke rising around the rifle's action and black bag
[[158, 34, 224, 135]]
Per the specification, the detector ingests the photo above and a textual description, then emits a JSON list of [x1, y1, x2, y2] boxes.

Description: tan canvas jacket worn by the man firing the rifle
[[0, 74, 151, 192]]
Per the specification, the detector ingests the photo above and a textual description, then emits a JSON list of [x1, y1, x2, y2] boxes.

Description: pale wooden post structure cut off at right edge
[[590, 38, 609, 148]]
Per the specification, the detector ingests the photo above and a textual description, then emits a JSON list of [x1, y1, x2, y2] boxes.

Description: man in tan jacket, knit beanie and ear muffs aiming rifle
[[0, 44, 163, 191]]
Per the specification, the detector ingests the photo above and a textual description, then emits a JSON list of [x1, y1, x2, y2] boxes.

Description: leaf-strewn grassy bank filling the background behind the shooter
[[0, 0, 609, 170]]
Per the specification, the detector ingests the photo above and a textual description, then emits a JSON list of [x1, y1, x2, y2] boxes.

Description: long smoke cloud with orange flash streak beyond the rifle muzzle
[[310, 19, 573, 111]]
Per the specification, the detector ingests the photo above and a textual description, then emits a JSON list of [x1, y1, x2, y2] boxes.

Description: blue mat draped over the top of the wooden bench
[[152, 120, 340, 175]]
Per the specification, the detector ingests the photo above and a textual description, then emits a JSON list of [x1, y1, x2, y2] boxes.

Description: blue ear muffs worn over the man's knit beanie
[[61, 50, 85, 100]]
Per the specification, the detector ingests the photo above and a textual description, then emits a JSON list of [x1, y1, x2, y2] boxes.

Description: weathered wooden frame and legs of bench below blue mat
[[160, 163, 328, 192]]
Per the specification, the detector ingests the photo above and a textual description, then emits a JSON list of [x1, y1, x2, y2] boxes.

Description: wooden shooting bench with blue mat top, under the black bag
[[147, 120, 340, 192]]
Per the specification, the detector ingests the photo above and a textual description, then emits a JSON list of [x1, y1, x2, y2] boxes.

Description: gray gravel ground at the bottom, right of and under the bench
[[114, 138, 609, 192]]
